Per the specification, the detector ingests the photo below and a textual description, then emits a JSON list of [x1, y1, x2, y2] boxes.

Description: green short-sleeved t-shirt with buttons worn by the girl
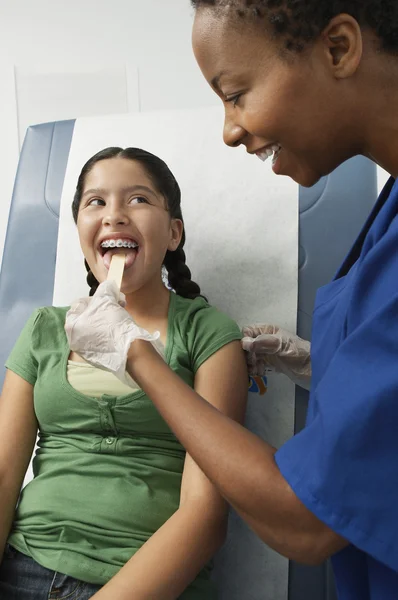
[[6, 293, 241, 600]]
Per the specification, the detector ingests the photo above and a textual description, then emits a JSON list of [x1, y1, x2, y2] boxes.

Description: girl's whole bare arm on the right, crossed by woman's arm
[[93, 342, 248, 600]]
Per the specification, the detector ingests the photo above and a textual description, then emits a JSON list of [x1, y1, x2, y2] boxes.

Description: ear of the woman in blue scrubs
[[321, 14, 363, 79]]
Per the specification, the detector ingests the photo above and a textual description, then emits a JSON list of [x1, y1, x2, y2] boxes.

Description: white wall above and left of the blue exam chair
[[0, 0, 221, 262]]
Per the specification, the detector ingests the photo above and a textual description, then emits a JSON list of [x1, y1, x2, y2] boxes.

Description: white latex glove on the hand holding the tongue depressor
[[65, 281, 162, 385]]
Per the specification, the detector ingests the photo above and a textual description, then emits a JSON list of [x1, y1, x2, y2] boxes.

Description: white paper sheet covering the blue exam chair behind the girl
[[54, 109, 298, 600]]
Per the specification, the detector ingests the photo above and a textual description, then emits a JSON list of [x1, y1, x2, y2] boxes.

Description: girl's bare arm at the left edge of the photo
[[0, 371, 37, 562]]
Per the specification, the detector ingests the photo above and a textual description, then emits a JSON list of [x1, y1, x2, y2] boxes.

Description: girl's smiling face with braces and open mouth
[[77, 158, 183, 294]]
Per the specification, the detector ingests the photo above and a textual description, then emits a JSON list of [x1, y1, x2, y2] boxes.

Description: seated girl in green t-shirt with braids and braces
[[0, 148, 247, 600]]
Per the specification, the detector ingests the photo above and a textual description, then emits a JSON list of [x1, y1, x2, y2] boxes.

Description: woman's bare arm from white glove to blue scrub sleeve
[[127, 342, 342, 563]]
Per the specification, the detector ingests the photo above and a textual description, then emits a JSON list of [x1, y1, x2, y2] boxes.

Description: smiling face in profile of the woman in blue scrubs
[[193, 8, 358, 186]]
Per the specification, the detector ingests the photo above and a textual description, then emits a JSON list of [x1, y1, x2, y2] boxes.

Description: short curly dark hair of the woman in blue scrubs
[[191, 0, 398, 54]]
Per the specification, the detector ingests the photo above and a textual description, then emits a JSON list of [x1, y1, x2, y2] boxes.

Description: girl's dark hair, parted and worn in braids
[[72, 147, 204, 299]]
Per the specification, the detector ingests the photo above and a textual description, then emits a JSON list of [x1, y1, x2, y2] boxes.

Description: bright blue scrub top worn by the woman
[[275, 178, 398, 600]]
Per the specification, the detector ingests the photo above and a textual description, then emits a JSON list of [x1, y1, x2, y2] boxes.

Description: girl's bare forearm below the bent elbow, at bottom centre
[[93, 502, 226, 600]]
